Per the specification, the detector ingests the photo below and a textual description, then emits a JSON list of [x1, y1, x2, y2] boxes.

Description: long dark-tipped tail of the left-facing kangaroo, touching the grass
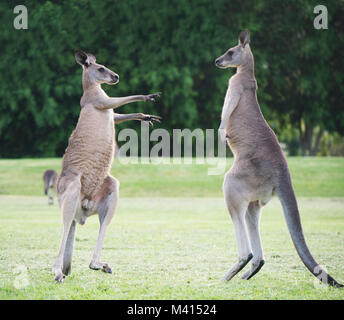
[[276, 171, 344, 287]]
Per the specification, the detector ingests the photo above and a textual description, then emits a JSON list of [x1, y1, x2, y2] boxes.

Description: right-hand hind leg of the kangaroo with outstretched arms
[[90, 176, 119, 273]]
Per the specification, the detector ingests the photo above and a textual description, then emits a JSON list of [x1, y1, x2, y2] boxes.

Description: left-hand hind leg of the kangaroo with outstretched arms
[[53, 175, 81, 282]]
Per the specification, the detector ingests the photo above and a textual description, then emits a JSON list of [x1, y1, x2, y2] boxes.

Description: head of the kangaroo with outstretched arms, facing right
[[75, 50, 119, 86]]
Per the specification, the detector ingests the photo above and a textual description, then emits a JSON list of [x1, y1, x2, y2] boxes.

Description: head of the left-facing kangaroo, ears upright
[[215, 30, 253, 69]]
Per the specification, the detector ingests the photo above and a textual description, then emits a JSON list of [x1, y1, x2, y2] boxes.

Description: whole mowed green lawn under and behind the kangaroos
[[0, 158, 344, 300]]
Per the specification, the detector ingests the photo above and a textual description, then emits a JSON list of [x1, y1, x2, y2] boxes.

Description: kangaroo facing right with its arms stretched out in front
[[53, 50, 160, 282]]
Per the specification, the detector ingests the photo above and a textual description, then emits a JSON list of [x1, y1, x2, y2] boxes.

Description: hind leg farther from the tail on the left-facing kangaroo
[[223, 175, 253, 281]]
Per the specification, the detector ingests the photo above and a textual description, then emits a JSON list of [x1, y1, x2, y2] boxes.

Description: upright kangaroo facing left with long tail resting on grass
[[215, 30, 343, 287]]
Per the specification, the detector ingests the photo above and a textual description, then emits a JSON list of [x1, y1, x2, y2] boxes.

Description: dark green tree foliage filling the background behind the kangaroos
[[0, 0, 344, 157]]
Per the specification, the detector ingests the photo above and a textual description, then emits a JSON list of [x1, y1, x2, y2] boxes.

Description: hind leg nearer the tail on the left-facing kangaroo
[[242, 201, 264, 280]]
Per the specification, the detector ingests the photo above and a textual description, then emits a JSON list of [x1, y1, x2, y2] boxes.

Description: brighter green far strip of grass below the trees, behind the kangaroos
[[0, 157, 344, 197]]
